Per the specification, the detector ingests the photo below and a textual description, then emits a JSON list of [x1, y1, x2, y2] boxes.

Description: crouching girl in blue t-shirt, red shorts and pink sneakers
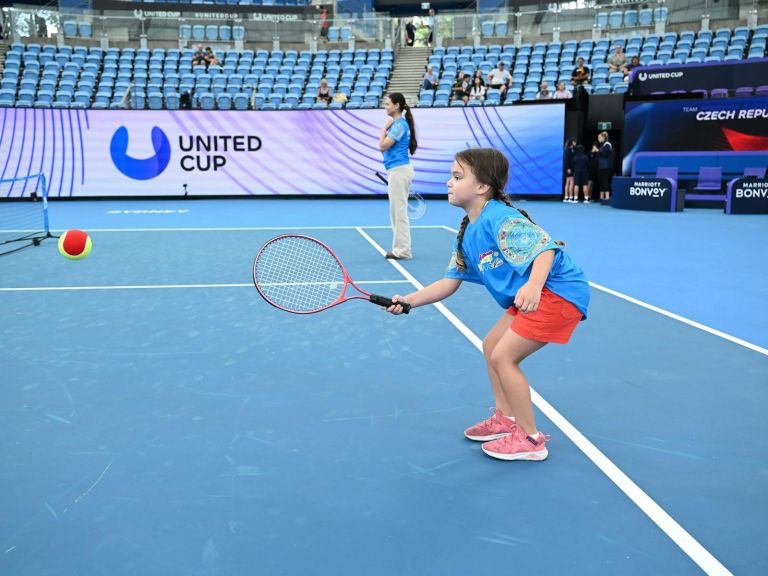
[[387, 148, 589, 460]]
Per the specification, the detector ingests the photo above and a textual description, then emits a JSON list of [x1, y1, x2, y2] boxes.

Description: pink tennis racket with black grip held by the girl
[[253, 234, 411, 314]]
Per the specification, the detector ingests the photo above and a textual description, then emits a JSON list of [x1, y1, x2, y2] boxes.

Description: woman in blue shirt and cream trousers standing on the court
[[379, 92, 417, 260]]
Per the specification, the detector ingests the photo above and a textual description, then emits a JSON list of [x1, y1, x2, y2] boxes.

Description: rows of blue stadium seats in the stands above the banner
[[0, 19, 768, 110]]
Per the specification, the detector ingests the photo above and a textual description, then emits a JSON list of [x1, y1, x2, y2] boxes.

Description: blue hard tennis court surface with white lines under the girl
[[0, 200, 768, 576]]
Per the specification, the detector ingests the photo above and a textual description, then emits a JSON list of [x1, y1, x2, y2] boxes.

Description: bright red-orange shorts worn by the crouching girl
[[507, 287, 582, 344]]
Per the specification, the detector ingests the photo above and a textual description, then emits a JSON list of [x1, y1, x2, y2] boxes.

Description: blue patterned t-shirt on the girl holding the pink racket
[[445, 200, 589, 319]]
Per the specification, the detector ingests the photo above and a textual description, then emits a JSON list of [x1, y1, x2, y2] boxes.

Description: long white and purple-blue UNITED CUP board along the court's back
[[0, 105, 565, 198]]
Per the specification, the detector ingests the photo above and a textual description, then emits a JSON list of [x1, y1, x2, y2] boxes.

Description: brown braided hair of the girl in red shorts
[[455, 148, 565, 272]]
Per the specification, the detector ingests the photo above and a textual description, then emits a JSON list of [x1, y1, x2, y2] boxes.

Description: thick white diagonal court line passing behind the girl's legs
[[358, 226, 732, 576]]
